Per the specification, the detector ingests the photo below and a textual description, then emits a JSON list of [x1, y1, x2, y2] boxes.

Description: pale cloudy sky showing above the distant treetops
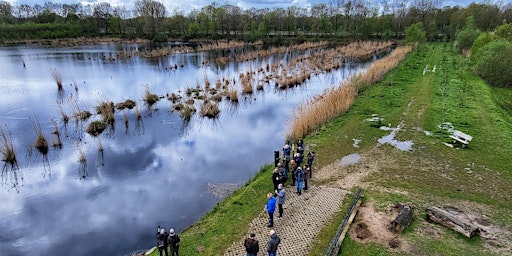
[[0, 0, 496, 14]]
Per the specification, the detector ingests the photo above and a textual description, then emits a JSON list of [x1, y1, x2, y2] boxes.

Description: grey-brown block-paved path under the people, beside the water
[[224, 185, 349, 256]]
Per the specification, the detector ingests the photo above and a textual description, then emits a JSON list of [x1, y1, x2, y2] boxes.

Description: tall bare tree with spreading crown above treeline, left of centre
[[135, 0, 167, 37]]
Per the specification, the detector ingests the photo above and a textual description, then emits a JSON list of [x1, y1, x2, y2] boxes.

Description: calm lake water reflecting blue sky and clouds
[[0, 45, 364, 255]]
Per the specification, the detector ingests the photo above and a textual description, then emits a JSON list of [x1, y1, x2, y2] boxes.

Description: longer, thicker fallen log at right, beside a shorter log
[[425, 207, 480, 238]]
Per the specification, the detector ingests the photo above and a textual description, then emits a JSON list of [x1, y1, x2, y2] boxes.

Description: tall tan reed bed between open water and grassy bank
[[286, 46, 411, 140]]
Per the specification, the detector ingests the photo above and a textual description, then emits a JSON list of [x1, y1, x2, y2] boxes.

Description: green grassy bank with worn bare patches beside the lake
[[146, 44, 512, 255]]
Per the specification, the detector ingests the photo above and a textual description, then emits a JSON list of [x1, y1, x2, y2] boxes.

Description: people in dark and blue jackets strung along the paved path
[[244, 139, 315, 256]]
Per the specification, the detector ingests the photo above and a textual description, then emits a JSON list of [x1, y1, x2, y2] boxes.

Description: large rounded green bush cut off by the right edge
[[475, 39, 512, 88]]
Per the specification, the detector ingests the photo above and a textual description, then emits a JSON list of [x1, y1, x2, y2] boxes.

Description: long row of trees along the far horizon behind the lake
[[0, 0, 512, 42]]
